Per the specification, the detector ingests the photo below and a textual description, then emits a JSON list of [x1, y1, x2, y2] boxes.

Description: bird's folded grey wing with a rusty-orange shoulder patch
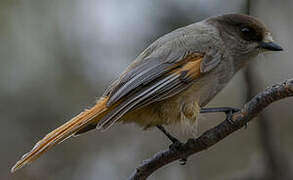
[[97, 48, 204, 129]]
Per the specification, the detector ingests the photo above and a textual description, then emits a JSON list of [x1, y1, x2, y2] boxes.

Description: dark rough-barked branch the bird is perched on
[[128, 79, 293, 180]]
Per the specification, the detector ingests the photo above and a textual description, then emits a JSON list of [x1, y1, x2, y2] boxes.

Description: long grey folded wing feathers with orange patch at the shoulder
[[97, 53, 204, 129]]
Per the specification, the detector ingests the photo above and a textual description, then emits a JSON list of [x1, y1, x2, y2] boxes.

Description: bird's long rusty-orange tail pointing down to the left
[[11, 98, 108, 172]]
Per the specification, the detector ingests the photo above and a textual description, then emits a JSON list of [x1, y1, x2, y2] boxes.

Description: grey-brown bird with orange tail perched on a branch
[[11, 13, 283, 172]]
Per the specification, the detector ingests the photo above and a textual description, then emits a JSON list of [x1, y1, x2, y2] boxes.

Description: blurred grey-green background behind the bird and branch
[[0, 0, 293, 180]]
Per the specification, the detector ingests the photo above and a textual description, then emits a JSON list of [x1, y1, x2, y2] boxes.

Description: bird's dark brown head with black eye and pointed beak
[[207, 14, 283, 56]]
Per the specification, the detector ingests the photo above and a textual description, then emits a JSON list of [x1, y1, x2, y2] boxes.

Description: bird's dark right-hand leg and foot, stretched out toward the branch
[[200, 107, 242, 126]]
